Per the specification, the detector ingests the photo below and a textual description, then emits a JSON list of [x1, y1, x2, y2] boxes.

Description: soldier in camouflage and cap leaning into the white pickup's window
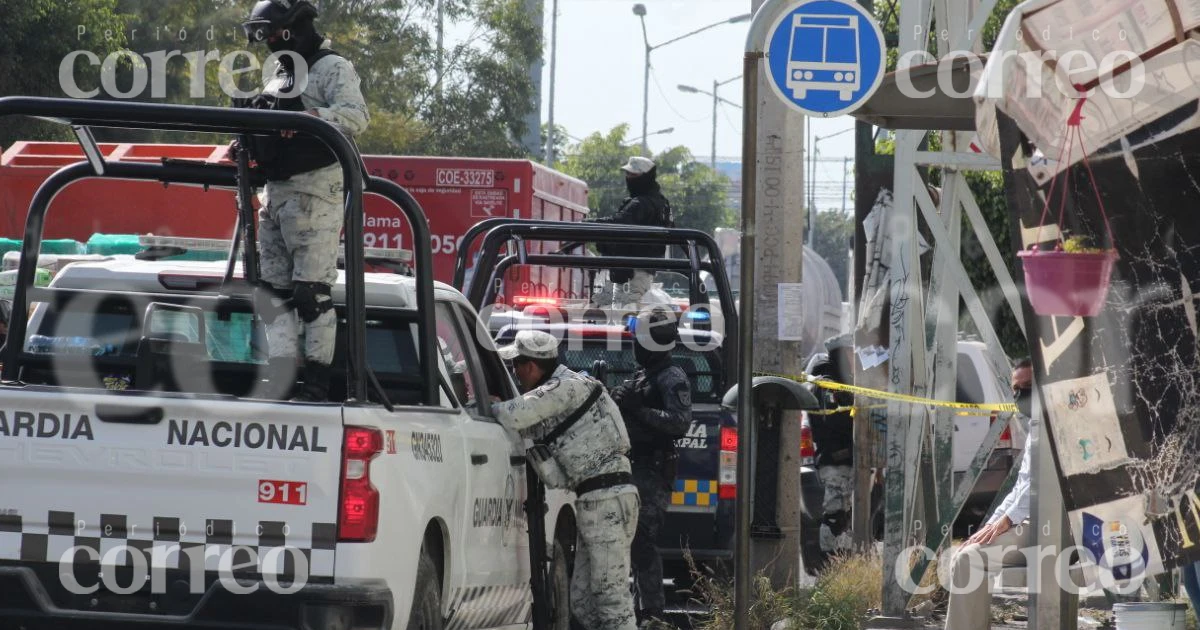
[[492, 330, 638, 630]]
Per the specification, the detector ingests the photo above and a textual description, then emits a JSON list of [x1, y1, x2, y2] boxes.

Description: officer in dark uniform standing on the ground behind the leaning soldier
[[612, 308, 691, 622]]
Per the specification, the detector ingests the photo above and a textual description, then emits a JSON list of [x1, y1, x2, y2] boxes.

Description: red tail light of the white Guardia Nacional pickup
[[337, 426, 383, 542]]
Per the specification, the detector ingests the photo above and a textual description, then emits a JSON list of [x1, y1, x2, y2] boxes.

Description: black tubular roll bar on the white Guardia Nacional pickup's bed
[[0, 96, 440, 404]]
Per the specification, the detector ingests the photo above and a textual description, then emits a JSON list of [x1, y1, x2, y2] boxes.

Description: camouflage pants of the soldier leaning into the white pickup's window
[[571, 486, 638, 630]]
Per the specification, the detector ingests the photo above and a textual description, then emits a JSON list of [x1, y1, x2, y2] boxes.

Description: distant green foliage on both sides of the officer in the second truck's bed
[[558, 125, 734, 233]]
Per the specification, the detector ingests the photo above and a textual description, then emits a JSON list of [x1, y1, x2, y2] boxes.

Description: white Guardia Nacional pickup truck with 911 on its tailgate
[[0, 257, 575, 629]]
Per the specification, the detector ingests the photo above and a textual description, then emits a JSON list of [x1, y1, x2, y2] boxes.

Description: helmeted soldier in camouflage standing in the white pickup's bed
[[235, 0, 370, 401]]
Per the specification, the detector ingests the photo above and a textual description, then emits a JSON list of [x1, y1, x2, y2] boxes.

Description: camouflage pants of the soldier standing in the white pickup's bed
[[258, 164, 343, 365]]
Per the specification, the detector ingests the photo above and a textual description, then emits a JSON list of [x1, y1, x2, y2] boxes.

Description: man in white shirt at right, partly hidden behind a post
[[946, 359, 1040, 630]]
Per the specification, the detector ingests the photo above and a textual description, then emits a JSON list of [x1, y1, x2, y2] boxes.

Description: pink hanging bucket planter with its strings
[[1016, 92, 1118, 317]]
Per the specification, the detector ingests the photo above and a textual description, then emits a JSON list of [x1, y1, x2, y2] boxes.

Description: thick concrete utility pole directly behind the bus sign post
[[738, 0, 808, 587]]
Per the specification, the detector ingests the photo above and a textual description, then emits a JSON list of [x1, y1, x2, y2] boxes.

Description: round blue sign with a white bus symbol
[[763, 0, 887, 118]]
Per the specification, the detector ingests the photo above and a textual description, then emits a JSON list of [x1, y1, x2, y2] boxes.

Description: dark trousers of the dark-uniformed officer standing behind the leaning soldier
[[632, 464, 671, 613]]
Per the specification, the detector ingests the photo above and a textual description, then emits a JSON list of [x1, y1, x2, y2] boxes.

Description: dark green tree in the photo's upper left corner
[[0, 0, 124, 148]]
